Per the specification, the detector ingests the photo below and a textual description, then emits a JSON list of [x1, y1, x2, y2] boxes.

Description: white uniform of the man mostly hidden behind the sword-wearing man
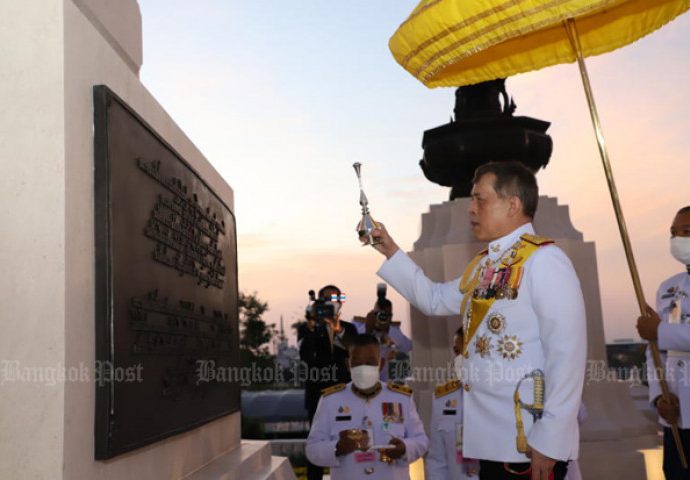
[[424, 380, 479, 480]]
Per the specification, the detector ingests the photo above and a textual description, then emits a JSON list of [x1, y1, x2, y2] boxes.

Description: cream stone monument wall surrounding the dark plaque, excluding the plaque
[[0, 0, 294, 480]]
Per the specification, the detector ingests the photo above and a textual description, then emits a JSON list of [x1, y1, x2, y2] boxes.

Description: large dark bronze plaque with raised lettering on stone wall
[[94, 86, 240, 459]]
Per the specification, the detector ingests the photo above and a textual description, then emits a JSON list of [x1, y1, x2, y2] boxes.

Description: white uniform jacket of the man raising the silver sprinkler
[[378, 223, 587, 462]]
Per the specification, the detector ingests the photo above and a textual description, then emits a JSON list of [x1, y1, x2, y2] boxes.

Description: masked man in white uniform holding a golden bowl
[[306, 334, 429, 480]]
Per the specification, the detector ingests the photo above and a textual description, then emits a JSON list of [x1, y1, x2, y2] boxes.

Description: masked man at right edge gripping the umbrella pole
[[637, 206, 690, 480]]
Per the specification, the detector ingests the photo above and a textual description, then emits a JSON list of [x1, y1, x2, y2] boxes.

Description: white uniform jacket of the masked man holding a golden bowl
[[306, 383, 429, 480]]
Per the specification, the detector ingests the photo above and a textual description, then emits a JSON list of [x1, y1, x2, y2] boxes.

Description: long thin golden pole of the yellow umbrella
[[564, 18, 688, 469]]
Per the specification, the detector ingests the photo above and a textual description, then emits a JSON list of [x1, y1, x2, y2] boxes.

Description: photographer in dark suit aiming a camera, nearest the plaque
[[297, 285, 357, 480]]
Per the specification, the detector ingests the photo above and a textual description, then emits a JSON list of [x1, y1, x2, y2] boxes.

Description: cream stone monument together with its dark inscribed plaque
[[0, 0, 294, 480]]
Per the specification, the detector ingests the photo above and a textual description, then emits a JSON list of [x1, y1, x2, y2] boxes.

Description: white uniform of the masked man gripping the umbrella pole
[[647, 272, 690, 429]]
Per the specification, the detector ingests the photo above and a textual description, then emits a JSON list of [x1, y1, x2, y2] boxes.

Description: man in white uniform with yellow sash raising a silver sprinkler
[[362, 162, 587, 480]]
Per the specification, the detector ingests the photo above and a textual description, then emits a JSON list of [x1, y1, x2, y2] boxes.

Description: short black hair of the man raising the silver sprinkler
[[472, 160, 539, 219]]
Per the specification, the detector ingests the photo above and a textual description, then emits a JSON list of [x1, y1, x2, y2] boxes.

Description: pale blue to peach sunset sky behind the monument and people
[[139, 0, 690, 341]]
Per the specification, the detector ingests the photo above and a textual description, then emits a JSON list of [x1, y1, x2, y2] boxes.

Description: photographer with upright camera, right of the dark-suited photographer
[[354, 283, 412, 382]]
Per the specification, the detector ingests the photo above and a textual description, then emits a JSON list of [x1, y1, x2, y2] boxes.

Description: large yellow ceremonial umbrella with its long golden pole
[[389, 0, 690, 468]]
